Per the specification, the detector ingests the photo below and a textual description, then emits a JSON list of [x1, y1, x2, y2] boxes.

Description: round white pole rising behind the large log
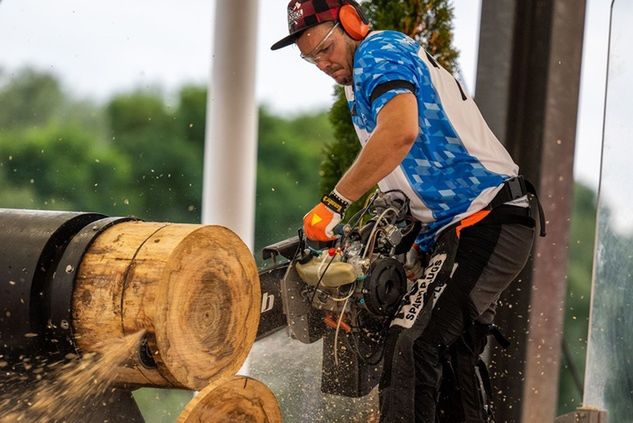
[[202, 0, 258, 250]]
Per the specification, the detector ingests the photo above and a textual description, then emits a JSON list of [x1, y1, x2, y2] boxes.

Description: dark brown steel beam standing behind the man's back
[[476, 0, 585, 422]]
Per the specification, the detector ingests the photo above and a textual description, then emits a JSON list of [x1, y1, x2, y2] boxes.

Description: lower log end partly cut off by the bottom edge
[[177, 376, 282, 423]]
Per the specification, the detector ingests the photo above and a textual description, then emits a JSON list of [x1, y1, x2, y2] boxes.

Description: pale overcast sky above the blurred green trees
[[0, 0, 621, 187]]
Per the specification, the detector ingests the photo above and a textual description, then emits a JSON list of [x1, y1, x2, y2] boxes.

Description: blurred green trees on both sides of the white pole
[[0, 69, 332, 251]]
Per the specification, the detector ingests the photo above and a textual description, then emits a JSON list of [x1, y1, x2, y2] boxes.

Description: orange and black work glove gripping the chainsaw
[[303, 190, 351, 241]]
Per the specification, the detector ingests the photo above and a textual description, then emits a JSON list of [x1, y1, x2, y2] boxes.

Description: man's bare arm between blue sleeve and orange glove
[[336, 93, 419, 201]]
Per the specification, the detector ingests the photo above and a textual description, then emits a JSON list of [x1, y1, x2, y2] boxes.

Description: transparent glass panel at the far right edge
[[584, 0, 633, 422]]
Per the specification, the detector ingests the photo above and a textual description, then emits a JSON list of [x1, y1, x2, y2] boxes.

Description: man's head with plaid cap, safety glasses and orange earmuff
[[271, 0, 369, 85]]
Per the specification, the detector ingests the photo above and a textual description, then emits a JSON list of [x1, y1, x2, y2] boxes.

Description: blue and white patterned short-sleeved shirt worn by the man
[[345, 31, 518, 251]]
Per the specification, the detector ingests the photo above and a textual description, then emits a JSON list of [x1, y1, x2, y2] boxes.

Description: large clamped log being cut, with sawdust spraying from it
[[72, 222, 261, 390]]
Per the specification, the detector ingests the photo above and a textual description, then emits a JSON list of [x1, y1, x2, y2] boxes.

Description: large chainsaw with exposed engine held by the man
[[257, 190, 420, 397]]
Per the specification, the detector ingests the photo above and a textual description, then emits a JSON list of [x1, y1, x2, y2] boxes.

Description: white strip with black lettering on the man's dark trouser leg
[[391, 254, 447, 329]]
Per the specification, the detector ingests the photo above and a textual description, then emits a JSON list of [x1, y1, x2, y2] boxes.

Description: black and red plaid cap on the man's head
[[270, 0, 341, 50]]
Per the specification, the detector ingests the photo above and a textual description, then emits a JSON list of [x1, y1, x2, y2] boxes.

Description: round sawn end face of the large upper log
[[156, 226, 261, 389]]
